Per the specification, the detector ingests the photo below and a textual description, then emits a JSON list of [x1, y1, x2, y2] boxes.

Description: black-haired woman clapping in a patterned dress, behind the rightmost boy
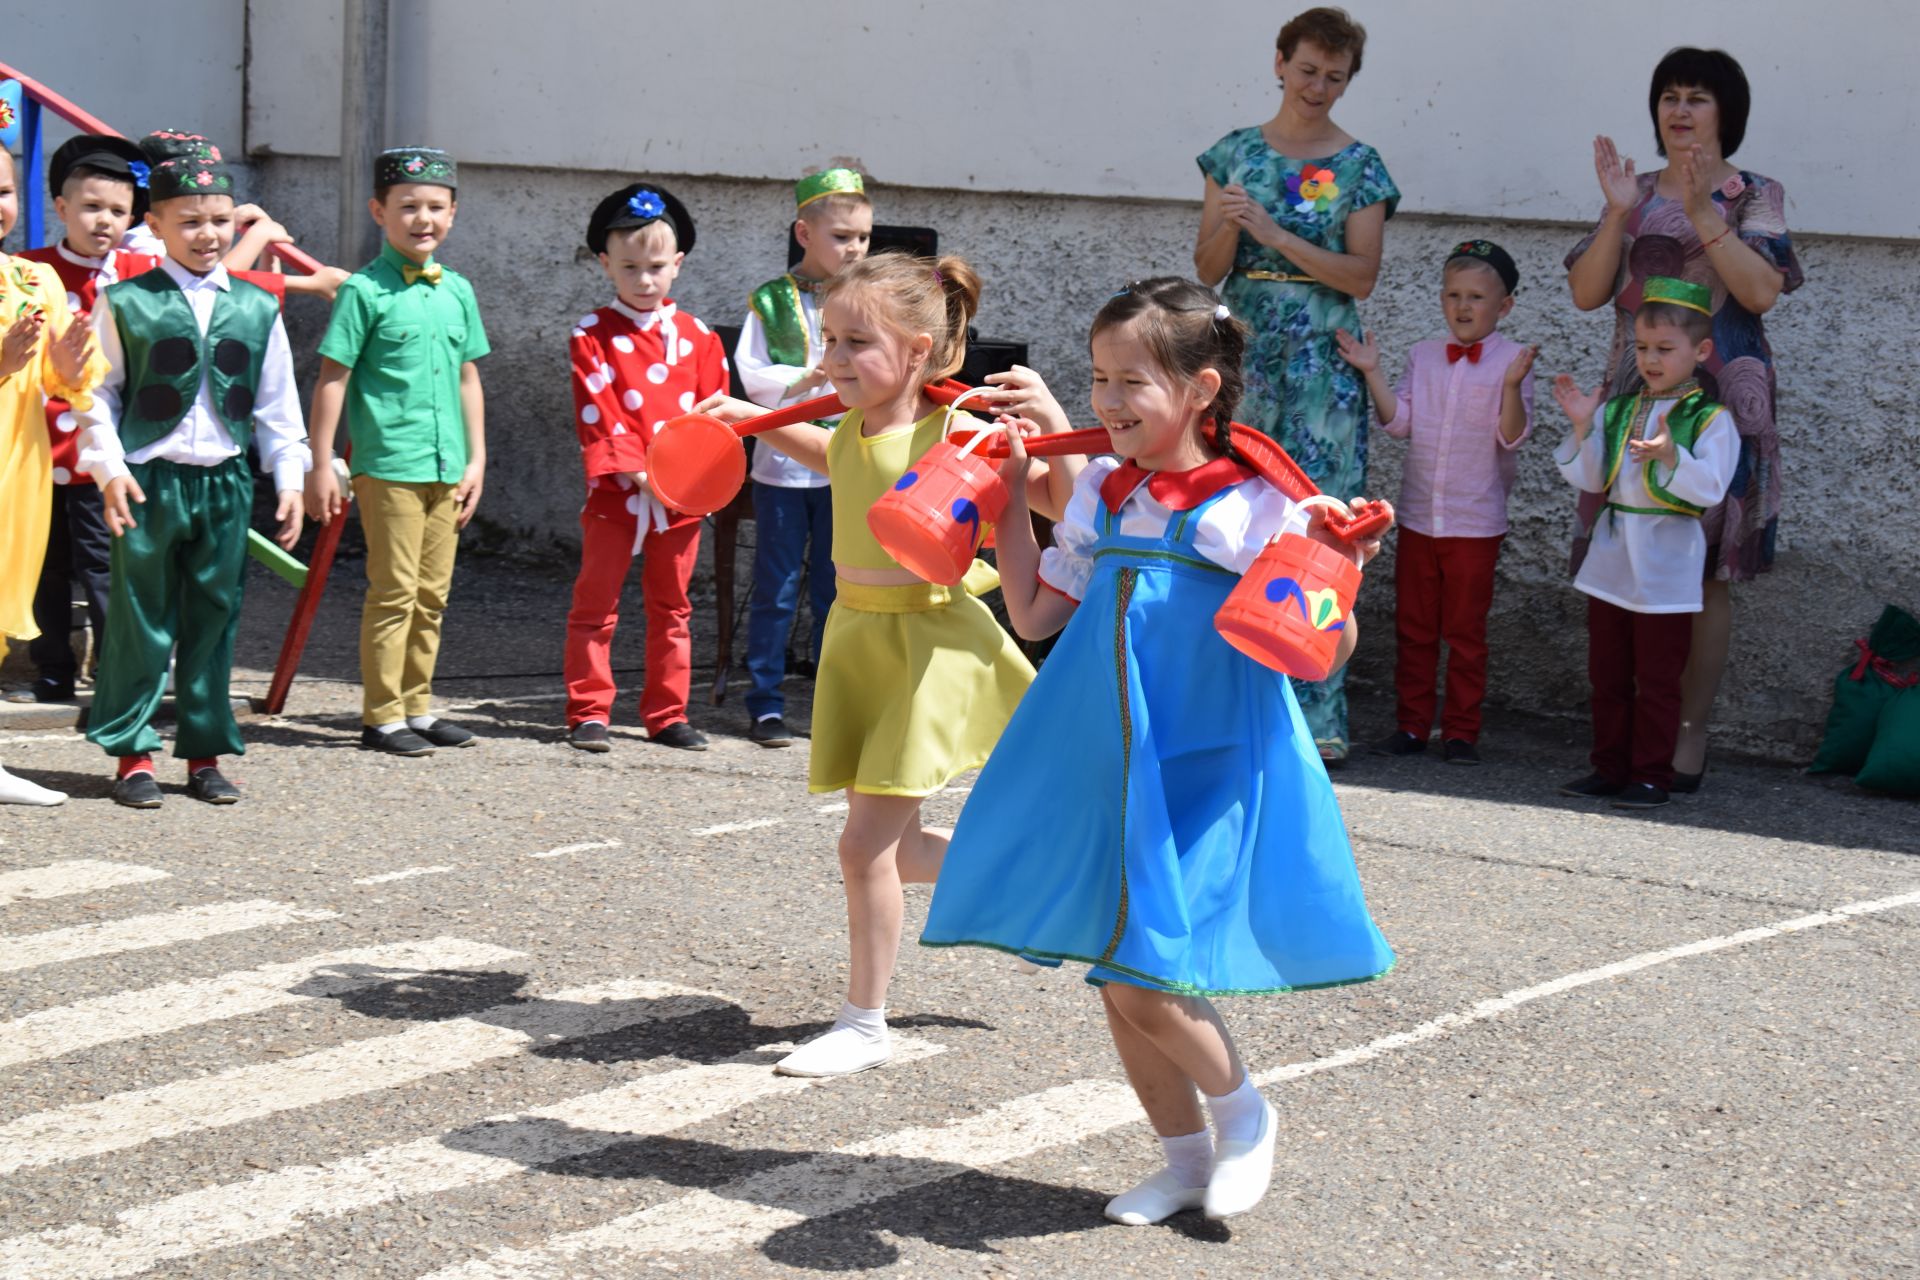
[[1567, 48, 1803, 791]]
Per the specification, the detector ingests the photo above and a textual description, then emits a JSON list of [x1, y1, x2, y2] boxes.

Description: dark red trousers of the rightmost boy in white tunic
[[1586, 597, 1693, 791]]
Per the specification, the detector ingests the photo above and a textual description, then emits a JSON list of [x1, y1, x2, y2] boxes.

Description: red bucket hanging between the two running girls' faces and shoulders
[[866, 397, 1008, 587]]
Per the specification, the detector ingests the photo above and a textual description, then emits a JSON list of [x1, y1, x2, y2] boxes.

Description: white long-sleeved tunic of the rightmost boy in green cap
[[1553, 399, 1740, 614]]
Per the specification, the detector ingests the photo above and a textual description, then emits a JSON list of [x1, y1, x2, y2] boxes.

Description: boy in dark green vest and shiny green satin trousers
[[81, 159, 311, 808]]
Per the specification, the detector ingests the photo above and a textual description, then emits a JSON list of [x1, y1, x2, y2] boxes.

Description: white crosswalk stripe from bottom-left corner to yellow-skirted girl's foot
[[0, 1038, 941, 1280]]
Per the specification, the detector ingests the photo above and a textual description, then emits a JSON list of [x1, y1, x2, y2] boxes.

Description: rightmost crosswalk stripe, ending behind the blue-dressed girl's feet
[[422, 1080, 1140, 1280]]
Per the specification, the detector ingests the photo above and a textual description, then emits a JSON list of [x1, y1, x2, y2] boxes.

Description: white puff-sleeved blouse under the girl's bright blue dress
[[1041, 457, 1308, 601]]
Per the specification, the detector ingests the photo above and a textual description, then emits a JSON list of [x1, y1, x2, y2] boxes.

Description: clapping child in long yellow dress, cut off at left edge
[[0, 152, 106, 804]]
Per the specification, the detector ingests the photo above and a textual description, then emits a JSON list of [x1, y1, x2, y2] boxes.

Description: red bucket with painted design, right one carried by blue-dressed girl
[[1213, 533, 1359, 679]]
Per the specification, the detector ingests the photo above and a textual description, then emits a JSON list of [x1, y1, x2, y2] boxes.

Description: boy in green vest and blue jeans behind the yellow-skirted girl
[[733, 169, 874, 747]]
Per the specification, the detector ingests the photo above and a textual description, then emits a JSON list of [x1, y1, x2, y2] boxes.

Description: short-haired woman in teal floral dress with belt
[[1194, 8, 1400, 764]]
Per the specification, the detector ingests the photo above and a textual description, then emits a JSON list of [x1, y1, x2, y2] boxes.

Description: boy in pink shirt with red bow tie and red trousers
[[1336, 240, 1536, 764]]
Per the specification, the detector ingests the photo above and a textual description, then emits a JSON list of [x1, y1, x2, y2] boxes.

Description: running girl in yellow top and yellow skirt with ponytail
[[701, 253, 1079, 1077]]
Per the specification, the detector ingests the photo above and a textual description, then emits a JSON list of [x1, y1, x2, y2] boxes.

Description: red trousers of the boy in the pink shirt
[[1394, 528, 1505, 743]]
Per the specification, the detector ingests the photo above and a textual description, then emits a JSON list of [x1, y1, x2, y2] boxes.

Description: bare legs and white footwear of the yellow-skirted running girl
[[778, 791, 948, 1075]]
